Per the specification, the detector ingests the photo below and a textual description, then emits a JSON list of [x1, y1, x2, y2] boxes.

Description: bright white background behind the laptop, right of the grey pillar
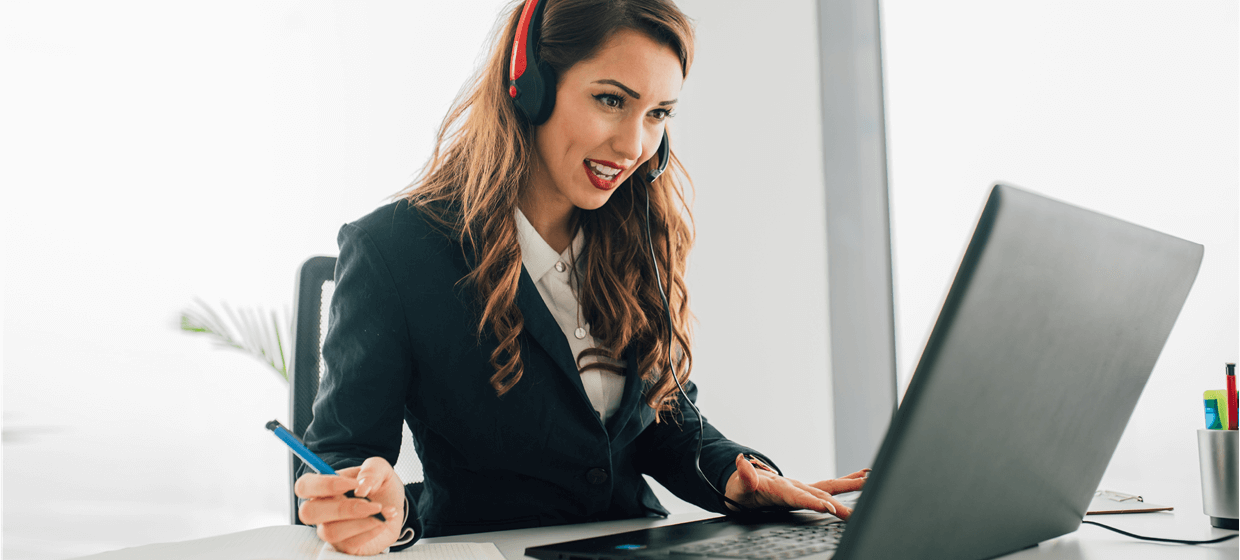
[[883, 0, 1240, 523]]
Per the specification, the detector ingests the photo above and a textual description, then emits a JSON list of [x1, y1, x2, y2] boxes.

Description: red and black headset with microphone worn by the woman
[[508, 0, 671, 182]]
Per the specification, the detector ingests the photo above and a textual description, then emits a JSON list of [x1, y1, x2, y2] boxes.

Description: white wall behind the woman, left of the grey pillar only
[[0, 0, 832, 560]]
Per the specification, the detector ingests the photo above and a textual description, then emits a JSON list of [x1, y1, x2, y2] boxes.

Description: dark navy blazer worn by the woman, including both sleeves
[[305, 201, 774, 547]]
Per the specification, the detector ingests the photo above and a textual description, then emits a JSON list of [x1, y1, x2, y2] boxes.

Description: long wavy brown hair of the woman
[[396, 0, 693, 421]]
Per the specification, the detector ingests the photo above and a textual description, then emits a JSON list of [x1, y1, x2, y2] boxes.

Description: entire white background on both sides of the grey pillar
[[0, 0, 1240, 559]]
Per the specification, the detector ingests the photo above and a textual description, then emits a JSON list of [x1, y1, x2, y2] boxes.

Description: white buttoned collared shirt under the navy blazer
[[517, 208, 624, 424]]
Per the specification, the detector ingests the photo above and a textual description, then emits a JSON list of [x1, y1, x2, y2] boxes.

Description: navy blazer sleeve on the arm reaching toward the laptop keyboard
[[636, 382, 782, 514]]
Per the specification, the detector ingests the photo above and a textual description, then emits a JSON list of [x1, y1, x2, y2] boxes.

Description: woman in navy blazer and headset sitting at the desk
[[296, 0, 864, 554]]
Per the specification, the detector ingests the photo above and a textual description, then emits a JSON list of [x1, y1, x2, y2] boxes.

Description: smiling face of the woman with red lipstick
[[531, 30, 683, 216]]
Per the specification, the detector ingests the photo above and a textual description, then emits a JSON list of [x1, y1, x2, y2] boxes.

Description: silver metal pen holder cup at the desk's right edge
[[1197, 430, 1240, 529]]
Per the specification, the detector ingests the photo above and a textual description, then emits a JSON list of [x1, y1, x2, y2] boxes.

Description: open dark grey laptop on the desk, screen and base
[[526, 185, 1204, 560]]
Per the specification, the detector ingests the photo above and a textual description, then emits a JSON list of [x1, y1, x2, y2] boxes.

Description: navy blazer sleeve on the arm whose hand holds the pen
[[299, 224, 422, 544]]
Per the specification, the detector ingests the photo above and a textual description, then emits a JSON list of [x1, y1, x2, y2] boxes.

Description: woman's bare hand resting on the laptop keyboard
[[724, 455, 869, 520]]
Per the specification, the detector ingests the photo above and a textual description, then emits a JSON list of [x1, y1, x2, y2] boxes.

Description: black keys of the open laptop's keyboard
[[668, 523, 844, 560]]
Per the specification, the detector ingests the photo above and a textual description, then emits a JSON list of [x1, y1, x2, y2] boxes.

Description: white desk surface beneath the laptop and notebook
[[75, 503, 1240, 560]]
